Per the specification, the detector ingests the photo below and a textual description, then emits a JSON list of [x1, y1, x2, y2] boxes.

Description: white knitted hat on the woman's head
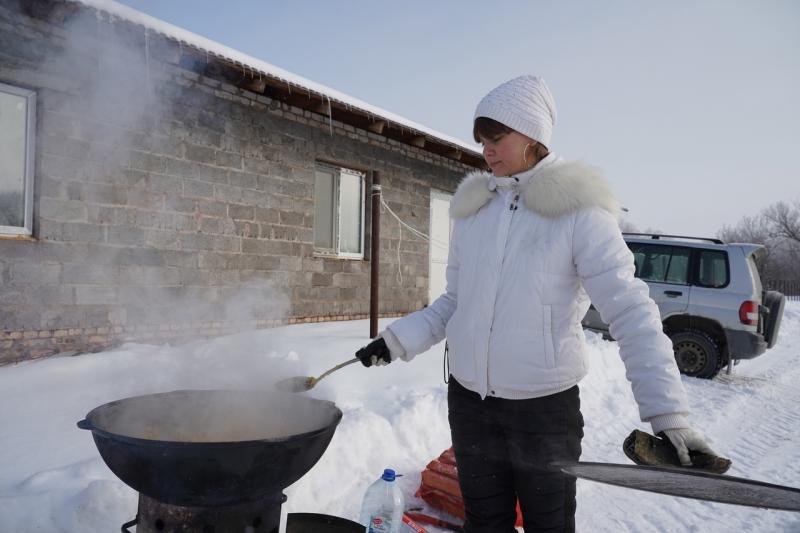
[[473, 75, 556, 148]]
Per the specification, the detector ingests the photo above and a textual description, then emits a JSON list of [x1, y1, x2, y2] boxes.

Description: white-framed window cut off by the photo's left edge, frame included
[[0, 83, 36, 235]]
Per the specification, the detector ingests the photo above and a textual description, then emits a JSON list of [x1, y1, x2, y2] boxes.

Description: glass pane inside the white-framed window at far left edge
[[0, 87, 28, 227]]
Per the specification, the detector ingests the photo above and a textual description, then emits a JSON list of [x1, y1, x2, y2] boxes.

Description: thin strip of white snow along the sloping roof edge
[[74, 0, 479, 153]]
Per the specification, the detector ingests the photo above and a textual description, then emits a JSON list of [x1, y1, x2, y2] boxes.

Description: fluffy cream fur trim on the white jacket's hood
[[450, 161, 621, 218]]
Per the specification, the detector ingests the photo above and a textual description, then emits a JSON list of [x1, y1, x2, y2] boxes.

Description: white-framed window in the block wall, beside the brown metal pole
[[314, 163, 366, 259]]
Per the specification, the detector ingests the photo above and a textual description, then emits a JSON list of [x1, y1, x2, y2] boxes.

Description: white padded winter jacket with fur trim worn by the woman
[[387, 154, 689, 432]]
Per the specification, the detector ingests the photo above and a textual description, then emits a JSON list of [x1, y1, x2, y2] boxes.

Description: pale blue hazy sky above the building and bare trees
[[115, 0, 800, 235]]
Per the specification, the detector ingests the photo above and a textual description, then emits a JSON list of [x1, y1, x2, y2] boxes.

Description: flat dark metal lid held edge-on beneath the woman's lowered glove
[[552, 462, 800, 512]]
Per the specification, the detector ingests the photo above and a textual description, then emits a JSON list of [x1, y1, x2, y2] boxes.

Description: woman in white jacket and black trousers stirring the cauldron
[[356, 76, 713, 533]]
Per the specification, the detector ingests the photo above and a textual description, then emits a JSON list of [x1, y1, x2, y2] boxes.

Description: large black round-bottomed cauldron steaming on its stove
[[78, 390, 342, 506]]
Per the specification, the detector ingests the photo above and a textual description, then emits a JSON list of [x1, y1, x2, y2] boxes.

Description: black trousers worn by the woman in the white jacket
[[447, 376, 583, 533]]
